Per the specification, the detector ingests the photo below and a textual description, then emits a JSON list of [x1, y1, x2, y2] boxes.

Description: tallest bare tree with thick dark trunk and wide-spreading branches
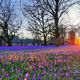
[[36, 0, 80, 39]]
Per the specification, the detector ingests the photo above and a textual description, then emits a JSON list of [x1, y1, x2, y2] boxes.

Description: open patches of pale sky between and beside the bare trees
[[14, 0, 80, 38]]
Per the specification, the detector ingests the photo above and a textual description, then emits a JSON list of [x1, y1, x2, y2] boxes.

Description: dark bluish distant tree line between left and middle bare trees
[[12, 36, 43, 46]]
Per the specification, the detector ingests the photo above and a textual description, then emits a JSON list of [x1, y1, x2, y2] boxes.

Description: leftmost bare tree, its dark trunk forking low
[[0, 0, 22, 46]]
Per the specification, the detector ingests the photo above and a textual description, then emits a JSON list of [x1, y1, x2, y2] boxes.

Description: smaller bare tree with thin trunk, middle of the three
[[24, 3, 50, 45]]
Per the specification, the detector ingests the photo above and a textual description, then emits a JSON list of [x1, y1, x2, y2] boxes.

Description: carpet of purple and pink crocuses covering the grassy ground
[[0, 46, 80, 80]]
